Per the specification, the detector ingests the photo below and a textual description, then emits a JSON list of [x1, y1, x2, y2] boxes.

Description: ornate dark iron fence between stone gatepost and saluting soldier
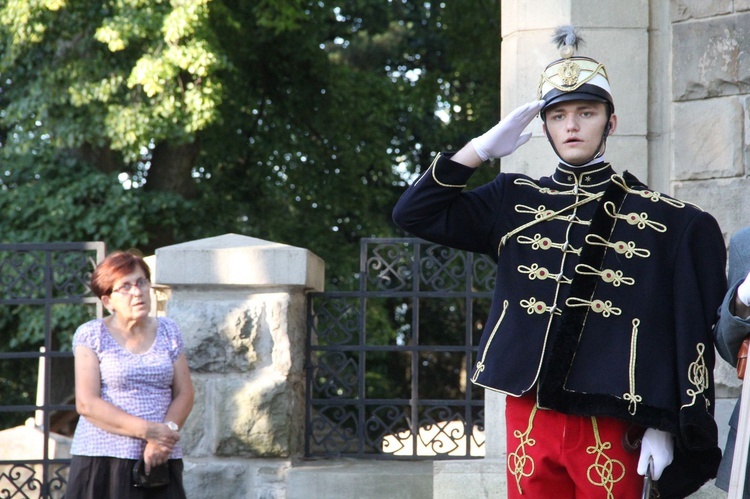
[[305, 238, 495, 459]]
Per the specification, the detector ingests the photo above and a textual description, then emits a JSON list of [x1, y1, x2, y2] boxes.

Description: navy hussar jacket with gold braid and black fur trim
[[393, 155, 726, 497]]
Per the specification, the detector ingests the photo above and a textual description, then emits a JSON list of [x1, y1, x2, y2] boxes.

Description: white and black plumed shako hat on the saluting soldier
[[537, 26, 615, 119]]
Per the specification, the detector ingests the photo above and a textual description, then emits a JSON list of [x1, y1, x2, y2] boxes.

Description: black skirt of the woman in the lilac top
[[63, 456, 186, 499]]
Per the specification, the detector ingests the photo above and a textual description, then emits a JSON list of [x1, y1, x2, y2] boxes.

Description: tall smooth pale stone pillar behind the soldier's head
[[500, 0, 652, 181]]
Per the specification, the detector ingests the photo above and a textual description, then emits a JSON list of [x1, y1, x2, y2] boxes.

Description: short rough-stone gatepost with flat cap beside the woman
[[155, 234, 324, 497]]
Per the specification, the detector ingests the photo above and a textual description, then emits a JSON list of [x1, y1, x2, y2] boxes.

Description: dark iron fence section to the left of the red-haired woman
[[0, 242, 105, 499]]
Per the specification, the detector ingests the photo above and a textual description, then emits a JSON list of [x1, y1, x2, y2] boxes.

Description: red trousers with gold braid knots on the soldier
[[505, 395, 643, 499]]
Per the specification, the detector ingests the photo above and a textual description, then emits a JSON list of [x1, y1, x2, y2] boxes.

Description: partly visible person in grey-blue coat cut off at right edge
[[715, 227, 750, 499]]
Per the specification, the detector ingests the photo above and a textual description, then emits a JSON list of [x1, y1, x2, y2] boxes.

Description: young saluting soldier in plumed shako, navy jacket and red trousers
[[393, 26, 726, 499]]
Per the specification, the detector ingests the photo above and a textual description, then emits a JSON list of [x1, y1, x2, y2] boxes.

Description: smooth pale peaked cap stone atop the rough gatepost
[[152, 234, 325, 291]]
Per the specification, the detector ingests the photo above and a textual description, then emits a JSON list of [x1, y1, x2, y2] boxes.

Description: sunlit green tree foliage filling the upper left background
[[0, 0, 506, 286]]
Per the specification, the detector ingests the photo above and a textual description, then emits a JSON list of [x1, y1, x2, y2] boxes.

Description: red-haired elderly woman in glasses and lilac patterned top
[[66, 252, 194, 499]]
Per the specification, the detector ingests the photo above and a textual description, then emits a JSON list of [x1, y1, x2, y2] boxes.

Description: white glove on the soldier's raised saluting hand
[[471, 100, 544, 161]]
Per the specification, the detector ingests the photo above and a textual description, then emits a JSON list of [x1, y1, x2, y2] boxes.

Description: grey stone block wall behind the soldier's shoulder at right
[[670, 0, 750, 242]]
